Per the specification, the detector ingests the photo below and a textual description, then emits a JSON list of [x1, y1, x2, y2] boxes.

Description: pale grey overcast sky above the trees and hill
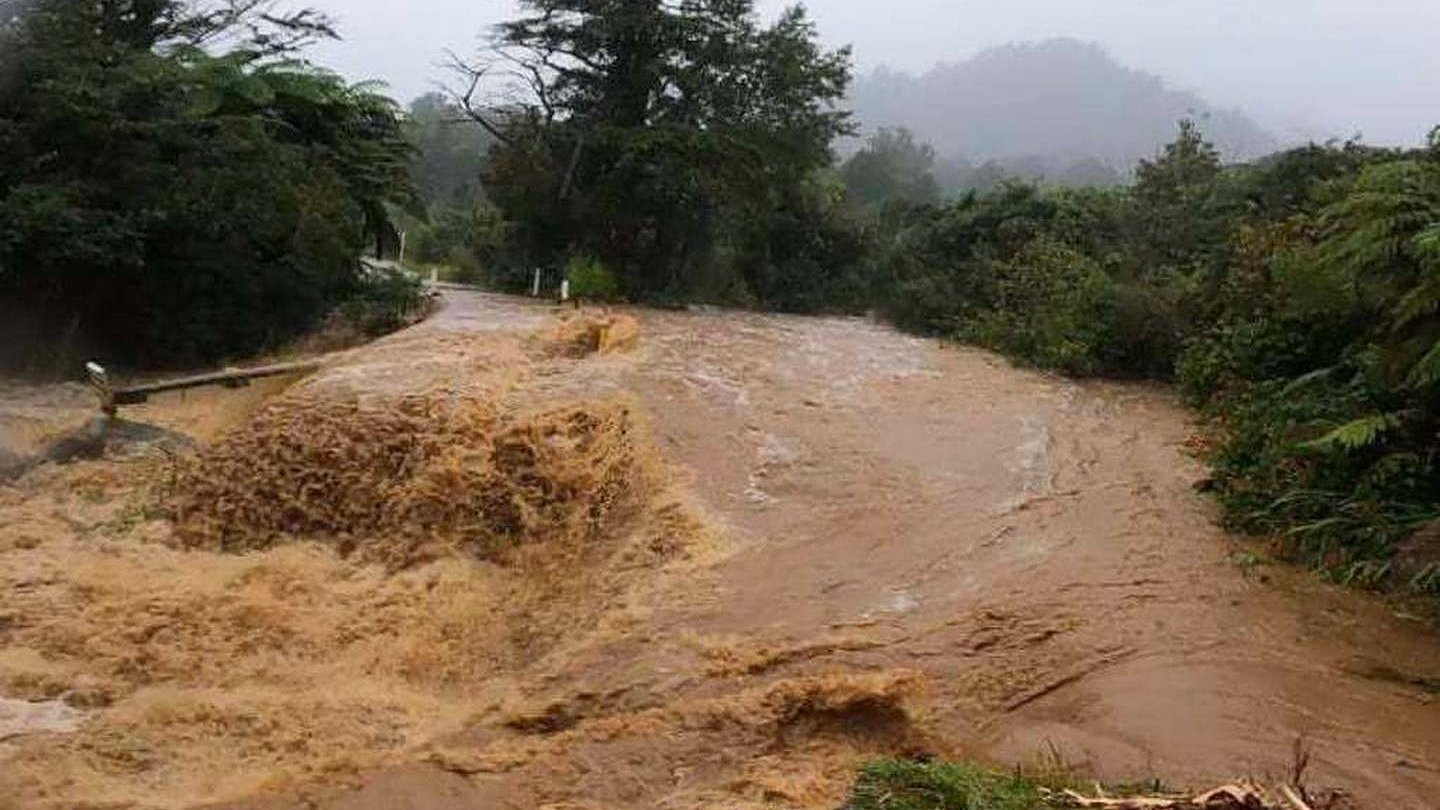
[[307, 0, 1440, 144]]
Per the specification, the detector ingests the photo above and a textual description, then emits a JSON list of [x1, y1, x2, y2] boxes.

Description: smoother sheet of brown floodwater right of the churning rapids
[[596, 299, 1440, 807]]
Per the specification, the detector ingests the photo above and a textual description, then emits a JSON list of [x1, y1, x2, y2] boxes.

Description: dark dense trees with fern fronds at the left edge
[[0, 0, 413, 375]]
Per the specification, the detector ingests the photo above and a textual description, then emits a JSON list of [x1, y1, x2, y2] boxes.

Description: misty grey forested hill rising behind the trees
[[850, 39, 1280, 170]]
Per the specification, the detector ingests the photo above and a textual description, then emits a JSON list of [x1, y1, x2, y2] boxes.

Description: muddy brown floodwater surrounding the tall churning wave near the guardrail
[[0, 293, 1440, 809]]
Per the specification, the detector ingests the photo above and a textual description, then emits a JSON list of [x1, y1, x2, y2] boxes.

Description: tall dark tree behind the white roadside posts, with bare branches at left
[[456, 0, 850, 297]]
